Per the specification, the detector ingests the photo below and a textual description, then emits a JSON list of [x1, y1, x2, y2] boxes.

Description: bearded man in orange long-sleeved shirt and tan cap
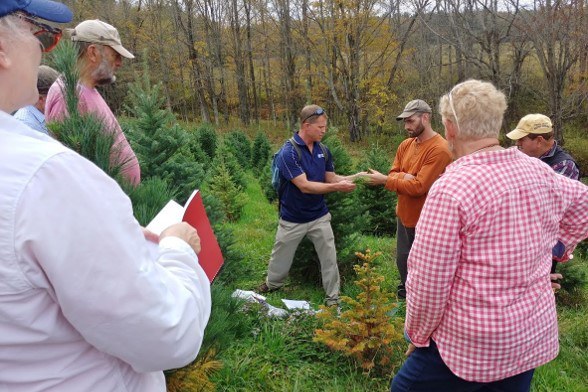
[[367, 99, 453, 298]]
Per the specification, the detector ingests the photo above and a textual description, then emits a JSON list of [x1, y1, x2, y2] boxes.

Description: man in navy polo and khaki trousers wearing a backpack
[[258, 105, 361, 306]]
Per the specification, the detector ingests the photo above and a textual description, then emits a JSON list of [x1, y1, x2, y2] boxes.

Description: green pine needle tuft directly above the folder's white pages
[[128, 177, 176, 226]]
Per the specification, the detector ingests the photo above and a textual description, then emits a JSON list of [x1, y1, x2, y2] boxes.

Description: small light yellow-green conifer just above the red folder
[[208, 162, 245, 222]]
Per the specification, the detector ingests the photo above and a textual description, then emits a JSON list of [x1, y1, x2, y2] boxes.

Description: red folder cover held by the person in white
[[182, 190, 224, 283]]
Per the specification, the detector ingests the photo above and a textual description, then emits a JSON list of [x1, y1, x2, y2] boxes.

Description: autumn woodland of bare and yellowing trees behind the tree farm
[[64, 0, 588, 142]]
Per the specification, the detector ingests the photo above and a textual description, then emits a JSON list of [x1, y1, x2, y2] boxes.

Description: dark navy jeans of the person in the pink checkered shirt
[[390, 340, 535, 392]]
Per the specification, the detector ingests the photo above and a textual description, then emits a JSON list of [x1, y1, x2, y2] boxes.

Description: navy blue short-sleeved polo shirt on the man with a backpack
[[278, 133, 335, 223]]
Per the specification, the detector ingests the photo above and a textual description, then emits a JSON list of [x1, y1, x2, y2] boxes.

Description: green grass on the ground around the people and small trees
[[204, 175, 588, 391]]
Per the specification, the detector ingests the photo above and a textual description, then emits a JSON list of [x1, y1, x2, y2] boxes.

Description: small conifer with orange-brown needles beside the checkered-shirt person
[[314, 249, 402, 374]]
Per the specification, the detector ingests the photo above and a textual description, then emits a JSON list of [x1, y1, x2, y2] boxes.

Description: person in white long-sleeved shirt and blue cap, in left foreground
[[0, 0, 211, 392]]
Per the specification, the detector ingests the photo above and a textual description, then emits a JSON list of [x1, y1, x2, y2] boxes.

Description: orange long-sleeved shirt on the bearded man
[[385, 134, 453, 227]]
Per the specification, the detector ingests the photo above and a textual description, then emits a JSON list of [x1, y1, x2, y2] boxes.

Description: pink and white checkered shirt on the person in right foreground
[[406, 148, 588, 382]]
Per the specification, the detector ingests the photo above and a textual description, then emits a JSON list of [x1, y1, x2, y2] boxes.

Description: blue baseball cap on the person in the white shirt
[[0, 0, 73, 23]]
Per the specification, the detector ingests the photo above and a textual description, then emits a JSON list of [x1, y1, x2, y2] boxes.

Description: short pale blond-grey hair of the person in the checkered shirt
[[439, 79, 507, 140]]
